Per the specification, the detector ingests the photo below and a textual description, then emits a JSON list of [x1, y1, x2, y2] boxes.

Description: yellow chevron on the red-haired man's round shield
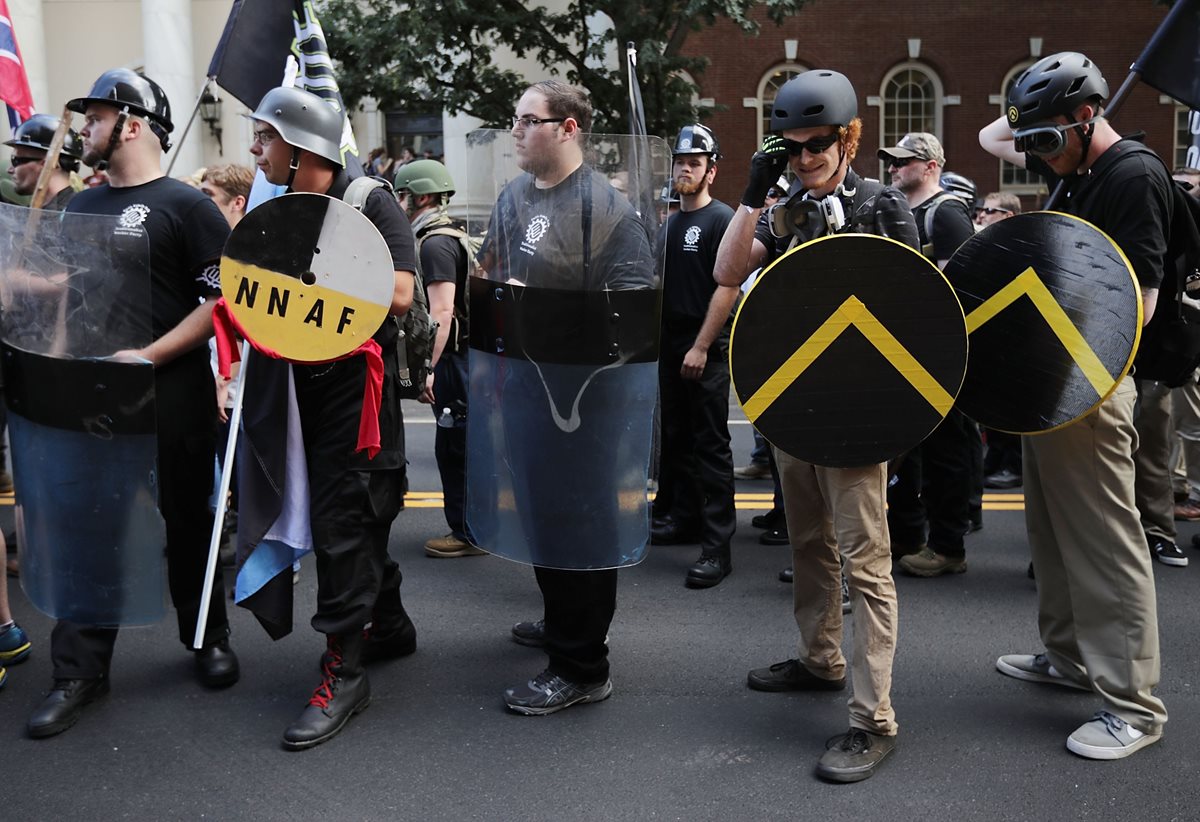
[[742, 295, 954, 422]]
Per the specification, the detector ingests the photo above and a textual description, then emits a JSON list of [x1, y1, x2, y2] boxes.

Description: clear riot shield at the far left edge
[[0, 205, 166, 625]]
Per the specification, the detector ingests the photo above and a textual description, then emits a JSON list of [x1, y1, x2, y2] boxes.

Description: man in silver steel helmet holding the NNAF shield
[[247, 88, 416, 750]]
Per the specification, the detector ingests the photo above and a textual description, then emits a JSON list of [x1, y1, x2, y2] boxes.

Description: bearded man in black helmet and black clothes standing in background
[[650, 124, 739, 588]]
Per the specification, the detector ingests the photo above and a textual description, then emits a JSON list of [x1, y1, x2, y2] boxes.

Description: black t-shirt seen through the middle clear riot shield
[[480, 166, 658, 290]]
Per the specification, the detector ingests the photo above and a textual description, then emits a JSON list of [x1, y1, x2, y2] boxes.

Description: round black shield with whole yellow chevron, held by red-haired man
[[730, 234, 967, 467]]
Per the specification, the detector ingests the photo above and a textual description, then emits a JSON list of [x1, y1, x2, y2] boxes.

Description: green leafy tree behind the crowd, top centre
[[320, 0, 809, 134]]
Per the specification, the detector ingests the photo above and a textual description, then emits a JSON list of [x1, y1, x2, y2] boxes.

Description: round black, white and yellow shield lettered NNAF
[[221, 193, 395, 362]]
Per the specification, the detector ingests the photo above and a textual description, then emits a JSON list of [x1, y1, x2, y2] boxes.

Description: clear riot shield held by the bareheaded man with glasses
[[467, 125, 670, 569]]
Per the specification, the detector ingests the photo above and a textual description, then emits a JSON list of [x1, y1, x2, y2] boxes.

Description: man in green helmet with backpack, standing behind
[[395, 160, 486, 558]]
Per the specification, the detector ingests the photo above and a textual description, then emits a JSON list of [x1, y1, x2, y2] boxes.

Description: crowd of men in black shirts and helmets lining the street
[[0, 53, 1200, 782]]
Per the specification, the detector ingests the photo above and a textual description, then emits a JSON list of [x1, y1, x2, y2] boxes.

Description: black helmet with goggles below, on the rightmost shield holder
[[1006, 52, 1109, 128]]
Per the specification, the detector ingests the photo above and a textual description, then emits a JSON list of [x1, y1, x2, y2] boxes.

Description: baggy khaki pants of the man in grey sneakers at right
[[1024, 378, 1166, 733]]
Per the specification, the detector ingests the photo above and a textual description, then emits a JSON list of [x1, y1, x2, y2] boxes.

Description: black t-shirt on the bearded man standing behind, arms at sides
[[656, 200, 733, 328]]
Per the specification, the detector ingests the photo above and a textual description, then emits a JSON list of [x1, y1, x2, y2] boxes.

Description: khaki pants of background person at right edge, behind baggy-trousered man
[[1133, 379, 1176, 542]]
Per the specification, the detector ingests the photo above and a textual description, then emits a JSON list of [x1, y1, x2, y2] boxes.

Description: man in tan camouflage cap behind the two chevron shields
[[878, 132, 983, 577]]
